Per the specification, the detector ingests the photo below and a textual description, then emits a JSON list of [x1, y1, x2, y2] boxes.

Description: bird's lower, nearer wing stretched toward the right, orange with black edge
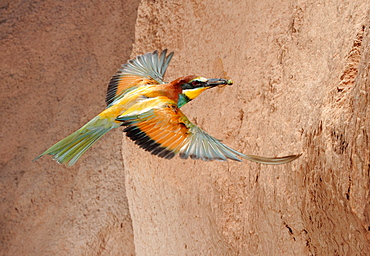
[[117, 97, 299, 164]]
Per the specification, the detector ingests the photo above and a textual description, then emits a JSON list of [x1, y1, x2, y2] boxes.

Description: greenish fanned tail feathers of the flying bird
[[33, 116, 119, 167]]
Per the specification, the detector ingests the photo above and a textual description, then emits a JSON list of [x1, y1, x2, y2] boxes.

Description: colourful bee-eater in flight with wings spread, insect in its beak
[[33, 49, 300, 167]]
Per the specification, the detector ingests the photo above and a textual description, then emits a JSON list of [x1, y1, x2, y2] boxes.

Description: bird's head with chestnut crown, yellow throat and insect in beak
[[177, 76, 233, 108]]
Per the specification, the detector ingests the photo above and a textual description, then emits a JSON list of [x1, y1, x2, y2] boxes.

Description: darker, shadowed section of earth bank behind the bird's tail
[[0, 0, 139, 256]]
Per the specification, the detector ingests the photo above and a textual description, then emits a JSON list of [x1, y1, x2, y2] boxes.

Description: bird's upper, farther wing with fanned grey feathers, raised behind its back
[[106, 49, 173, 106]]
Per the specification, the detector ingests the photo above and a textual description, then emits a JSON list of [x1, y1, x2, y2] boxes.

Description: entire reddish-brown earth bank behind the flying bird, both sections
[[0, 0, 370, 255]]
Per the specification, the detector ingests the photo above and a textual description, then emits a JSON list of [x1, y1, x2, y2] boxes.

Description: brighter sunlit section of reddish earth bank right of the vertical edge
[[123, 0, 370, 255]]
